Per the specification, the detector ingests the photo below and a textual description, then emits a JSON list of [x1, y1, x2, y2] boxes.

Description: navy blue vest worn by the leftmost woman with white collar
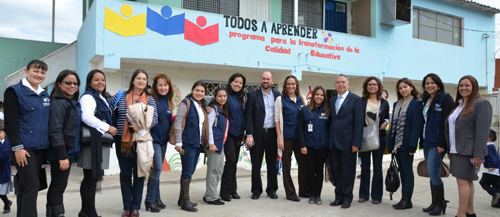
[[9, 81, 50, 150]]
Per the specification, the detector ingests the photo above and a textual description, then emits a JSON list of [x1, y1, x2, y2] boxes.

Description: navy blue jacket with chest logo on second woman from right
[[421, 93, 454, 149]]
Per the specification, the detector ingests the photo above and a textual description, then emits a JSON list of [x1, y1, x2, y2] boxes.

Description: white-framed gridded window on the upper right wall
[[413, 8, 463, 46]]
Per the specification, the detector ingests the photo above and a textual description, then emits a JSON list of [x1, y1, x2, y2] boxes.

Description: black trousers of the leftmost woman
[[10, 150, 45, 217]]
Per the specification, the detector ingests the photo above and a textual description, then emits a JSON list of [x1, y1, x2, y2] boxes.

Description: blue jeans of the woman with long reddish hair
[[146, 143, 167, 203]]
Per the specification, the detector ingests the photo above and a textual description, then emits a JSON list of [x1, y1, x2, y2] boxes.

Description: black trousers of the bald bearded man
[[250, 129, 278, 195]]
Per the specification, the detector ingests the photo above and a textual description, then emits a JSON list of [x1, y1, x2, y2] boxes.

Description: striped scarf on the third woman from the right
[[392, 96, 413, 154]]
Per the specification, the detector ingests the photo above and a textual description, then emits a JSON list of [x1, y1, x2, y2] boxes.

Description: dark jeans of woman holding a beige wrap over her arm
[[115, 136, 144, 210]]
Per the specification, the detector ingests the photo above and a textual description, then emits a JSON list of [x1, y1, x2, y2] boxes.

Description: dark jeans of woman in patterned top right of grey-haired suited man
[[358, 136, 386, 202]]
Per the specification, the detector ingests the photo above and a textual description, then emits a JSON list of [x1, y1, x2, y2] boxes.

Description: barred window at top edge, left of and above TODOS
[[182, 0, 240, 16]]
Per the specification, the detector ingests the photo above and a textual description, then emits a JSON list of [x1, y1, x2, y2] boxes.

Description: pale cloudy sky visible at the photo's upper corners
[[0, 0, 500, 45]]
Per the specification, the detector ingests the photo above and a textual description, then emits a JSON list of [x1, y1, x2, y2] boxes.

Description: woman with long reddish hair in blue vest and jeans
[[144, 74, 174, 212]]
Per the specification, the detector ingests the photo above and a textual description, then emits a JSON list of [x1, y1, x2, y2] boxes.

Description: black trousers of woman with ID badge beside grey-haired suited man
[[306, 148, 328, 196]]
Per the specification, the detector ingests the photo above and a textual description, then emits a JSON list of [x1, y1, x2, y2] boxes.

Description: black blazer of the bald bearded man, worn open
[[245, 88, 280, 142]]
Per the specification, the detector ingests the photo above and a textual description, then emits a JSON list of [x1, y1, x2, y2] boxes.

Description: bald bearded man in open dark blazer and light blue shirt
[[245, 71, 280, 200]]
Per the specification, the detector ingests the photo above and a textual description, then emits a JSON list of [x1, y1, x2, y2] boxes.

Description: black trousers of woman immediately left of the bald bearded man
[[220, 135, 243, 198]]
